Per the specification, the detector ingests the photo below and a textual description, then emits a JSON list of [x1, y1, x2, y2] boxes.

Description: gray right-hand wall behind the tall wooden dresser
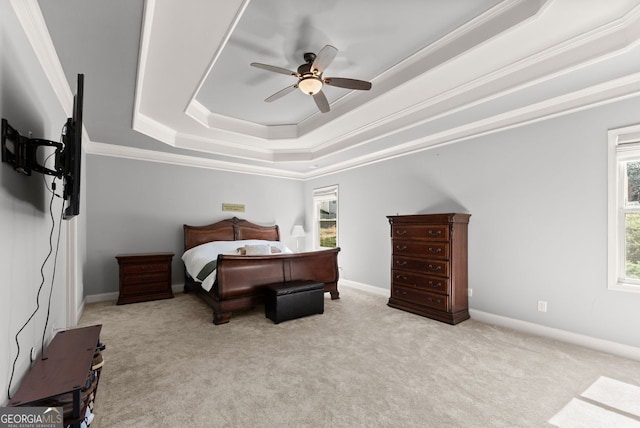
[[305, 94, 640, 346]]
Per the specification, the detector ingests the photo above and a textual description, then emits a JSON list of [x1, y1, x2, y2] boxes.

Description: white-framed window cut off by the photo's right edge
[[608, 122, 640, 293]]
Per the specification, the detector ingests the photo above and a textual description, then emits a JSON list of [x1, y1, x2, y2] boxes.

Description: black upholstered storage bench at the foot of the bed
[[264, 281, 324, 324]]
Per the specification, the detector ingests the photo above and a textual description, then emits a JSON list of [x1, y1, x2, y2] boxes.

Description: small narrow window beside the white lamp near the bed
[[313, 186, 338, 248]]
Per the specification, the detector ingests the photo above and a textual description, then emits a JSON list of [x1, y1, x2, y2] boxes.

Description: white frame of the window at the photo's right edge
[[607, 125, 640, 293]]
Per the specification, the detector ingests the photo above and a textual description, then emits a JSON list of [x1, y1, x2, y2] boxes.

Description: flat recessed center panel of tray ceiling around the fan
[[196, 0, 500, 125]]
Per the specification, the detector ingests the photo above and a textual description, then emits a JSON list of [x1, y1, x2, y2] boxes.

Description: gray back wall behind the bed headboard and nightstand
[[84, 155, 304, 295]]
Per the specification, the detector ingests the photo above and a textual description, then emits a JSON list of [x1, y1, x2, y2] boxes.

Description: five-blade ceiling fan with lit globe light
[[251, 45, 371, 113]]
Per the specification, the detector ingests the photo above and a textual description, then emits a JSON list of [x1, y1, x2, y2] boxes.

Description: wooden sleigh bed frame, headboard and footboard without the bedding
[[184, 217, 340, 325]]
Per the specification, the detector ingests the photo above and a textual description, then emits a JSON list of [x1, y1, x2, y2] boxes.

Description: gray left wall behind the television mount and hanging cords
[[0, 1, 71, 404]]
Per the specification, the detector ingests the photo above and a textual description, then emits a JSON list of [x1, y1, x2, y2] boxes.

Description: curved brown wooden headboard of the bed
[[183, 217, 280, 251]]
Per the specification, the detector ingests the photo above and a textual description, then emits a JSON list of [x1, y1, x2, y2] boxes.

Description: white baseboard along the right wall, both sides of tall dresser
[[340, 279, 640, 361]]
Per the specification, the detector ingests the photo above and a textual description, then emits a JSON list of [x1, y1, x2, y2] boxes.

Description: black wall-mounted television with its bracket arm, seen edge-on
[[0, 74, 84, 220]]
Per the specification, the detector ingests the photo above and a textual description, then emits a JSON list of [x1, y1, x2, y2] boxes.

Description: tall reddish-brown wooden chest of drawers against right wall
[[387, 213, 471, 324]]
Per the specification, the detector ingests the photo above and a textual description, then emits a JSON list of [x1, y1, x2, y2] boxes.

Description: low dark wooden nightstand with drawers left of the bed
[[116, 253, 173, 305]]
